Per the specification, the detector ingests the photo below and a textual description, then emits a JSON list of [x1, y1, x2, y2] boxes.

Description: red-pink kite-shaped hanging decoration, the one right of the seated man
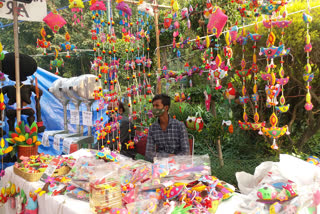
[[207, 7, 228, 38]]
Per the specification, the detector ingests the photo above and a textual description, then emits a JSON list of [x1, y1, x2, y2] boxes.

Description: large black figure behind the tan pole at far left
[[1, 53, 45, 135]]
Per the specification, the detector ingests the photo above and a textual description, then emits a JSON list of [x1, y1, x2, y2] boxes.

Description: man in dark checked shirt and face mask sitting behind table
[[146, 94, 190, 161]]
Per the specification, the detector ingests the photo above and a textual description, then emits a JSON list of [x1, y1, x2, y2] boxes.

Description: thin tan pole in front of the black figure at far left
[[12, 1, 21, 122]]
